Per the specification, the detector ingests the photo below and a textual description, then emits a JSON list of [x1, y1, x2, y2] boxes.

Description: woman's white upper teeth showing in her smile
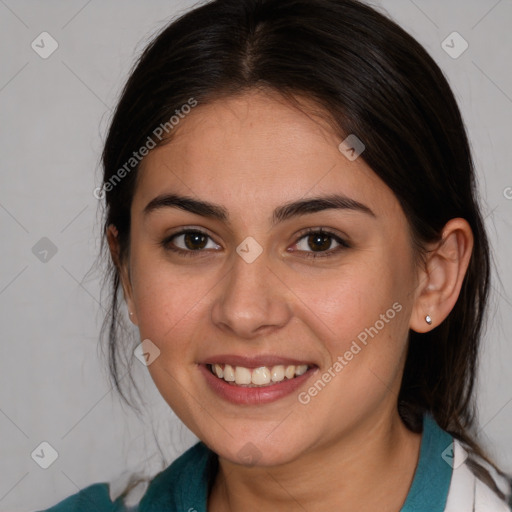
[[210, 364, 308, 386]]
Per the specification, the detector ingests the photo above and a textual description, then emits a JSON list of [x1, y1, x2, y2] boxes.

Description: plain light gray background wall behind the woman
[[0, 0, 512, 511]]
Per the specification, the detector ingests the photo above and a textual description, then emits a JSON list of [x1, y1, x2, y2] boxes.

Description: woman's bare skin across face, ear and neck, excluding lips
[[109, 91, 473, 512]]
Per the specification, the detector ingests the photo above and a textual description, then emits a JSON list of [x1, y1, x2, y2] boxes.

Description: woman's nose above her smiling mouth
[[211, 252, 292, 339]]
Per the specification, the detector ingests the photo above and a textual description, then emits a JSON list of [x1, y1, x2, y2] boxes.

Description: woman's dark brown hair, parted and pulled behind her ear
[[97, 0, 503, 504]]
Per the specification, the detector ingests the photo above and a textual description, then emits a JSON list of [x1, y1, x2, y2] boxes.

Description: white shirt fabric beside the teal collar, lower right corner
[[444, 439, 511, 512]]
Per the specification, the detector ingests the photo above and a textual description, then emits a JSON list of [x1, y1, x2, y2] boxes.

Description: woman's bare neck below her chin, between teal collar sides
[[208, 411, 421, 512]]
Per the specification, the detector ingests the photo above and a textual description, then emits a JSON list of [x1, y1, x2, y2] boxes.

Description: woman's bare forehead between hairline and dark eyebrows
[[134, 91, 397, 222]]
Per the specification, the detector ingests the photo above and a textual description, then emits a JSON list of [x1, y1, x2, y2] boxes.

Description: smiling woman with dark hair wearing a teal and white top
[[39, 0, 510, 512]]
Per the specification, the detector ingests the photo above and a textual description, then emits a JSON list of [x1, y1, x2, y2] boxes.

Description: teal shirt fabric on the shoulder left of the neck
[[38, 442, 213, 512]]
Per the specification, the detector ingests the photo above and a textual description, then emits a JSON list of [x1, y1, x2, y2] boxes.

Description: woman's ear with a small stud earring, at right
[[409, 218, 473, 333]]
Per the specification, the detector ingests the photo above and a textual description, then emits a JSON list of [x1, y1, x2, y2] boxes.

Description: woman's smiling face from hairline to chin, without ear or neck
[[125, 92, 418, 465]]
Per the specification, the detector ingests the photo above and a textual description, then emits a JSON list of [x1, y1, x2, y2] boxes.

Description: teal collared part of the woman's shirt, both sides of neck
[[41, 414, 453, 512]]
